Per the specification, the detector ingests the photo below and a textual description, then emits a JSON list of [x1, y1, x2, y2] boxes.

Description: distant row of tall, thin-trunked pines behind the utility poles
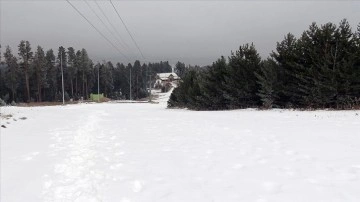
[[0, 40, 172, 103]]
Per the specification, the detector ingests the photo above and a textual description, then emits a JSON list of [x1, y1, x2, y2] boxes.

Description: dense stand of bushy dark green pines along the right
[[168, 20, 360, 110]]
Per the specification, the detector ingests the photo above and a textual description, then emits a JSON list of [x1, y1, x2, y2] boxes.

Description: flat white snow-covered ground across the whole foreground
[[0, 93, 360, 202]]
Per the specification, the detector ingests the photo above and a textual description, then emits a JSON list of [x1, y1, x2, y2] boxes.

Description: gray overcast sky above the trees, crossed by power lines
[[0, 0, 360, 65]]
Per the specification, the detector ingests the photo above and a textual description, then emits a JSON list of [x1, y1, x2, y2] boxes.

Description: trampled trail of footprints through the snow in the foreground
[[43, 112, 105, 202]]
